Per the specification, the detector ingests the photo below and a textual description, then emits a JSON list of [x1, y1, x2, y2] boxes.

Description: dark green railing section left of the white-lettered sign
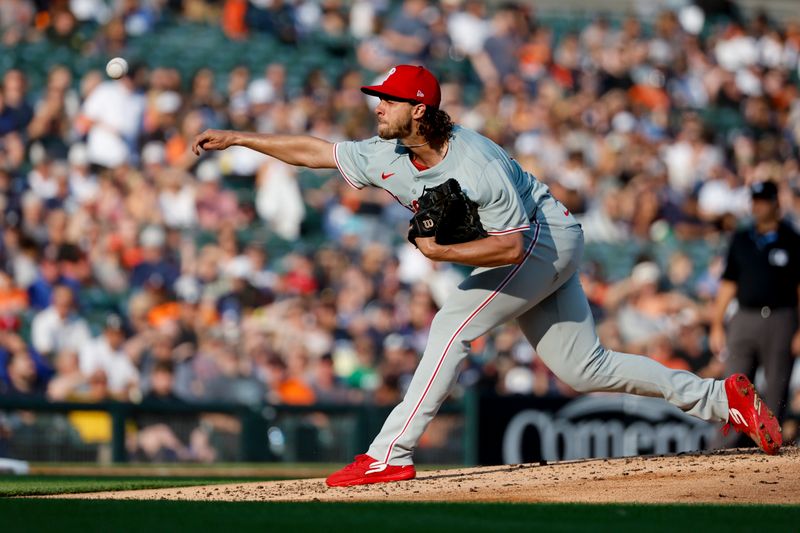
[[0, 394, 477, 465]]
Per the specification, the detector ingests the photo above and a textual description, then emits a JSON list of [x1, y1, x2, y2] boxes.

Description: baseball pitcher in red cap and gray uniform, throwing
[[192, 65, 782, 486]]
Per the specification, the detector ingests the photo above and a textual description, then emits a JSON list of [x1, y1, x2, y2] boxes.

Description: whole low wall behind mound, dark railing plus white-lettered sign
[[0, 391, 718, 465]]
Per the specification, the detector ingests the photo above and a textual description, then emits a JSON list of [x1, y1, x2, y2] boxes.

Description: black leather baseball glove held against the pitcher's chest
[[408, 178, 488, 246]]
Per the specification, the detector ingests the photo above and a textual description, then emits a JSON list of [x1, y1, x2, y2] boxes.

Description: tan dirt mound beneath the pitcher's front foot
[[51, 447, 800, 504]]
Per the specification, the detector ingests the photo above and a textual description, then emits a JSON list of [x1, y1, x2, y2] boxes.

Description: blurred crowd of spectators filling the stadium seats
[[0, 0, 800, 432]]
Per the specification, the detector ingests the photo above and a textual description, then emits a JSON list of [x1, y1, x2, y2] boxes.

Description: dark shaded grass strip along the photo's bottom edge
[[0, 499, 800, 533]]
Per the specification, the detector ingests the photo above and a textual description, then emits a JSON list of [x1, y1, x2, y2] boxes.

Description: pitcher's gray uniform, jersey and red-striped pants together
[[334, 127, 728, 467]]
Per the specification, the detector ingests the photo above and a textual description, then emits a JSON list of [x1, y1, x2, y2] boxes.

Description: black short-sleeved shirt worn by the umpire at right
[[722, 222, 800, 309]]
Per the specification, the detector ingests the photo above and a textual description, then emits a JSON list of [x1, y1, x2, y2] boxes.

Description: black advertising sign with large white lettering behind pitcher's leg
[[478, 394, 719, 464]]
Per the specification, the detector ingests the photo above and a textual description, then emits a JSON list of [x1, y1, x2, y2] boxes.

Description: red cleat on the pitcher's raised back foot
[[722, 374, 783, 455]]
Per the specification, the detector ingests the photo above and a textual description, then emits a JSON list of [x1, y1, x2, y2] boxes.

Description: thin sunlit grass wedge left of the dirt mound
[[0, 476, 275, 496]]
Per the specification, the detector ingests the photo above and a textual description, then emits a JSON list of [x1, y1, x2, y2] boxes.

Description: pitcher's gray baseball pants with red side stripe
[[367, 198, 728, 465]]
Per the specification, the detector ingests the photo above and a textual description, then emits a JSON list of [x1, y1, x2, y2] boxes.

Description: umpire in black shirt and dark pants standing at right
[[709, 181, 800, 434]]
